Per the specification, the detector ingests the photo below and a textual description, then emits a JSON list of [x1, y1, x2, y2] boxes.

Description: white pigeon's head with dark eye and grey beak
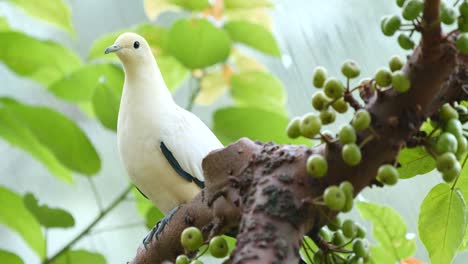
[[104, 32, 153, 66]]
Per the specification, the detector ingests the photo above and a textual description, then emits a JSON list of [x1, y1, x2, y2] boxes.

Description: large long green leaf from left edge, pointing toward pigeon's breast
[[0, 98, 101, 175]]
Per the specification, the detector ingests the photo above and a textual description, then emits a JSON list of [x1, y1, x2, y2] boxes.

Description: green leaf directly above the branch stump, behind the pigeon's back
[[213, 107, 311, 145]]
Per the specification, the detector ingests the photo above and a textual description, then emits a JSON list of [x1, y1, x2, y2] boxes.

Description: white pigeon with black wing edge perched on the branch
[[105, 33, 223, 241]]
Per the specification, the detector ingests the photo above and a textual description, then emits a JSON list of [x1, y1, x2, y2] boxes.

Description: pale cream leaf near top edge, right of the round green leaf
[[224, 8, 272, 31]]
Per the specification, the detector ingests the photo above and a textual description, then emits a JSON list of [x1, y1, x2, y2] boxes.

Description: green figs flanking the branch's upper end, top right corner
[[380, 0, 468, 54]]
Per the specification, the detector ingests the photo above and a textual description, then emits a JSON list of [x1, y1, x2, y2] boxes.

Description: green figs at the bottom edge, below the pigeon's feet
[[175, 226, 229, 264]]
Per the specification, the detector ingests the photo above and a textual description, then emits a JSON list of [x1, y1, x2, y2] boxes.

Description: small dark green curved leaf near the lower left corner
[[23, 193, 75, 228]]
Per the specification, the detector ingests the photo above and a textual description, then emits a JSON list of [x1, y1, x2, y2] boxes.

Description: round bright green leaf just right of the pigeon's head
[[168, 19, 231, 69]]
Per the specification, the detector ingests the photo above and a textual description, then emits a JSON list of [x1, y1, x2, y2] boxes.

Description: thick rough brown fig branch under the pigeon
[[132, 0, 468, 263]]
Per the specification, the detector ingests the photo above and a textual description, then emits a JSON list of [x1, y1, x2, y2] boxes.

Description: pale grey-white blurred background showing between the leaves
[[0, 0, 468, 264]]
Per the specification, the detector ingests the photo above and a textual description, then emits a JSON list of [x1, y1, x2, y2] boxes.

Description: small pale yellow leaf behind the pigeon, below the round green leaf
[[195, 71, 228, 105]]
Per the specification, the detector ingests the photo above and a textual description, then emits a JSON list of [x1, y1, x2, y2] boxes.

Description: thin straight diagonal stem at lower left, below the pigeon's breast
[[42, 184, 133, 264]]
